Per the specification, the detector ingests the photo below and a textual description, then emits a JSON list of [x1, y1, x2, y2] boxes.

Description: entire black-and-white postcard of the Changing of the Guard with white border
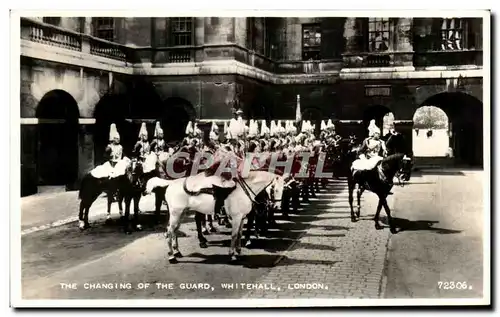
[[10, 10, 491, 308]]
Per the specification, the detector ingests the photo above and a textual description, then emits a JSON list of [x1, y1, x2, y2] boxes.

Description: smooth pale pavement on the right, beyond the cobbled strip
[[385, 169, 484, 298]]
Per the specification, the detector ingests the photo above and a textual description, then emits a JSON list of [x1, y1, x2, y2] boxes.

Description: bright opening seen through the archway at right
[[412, 106, 450, 157]]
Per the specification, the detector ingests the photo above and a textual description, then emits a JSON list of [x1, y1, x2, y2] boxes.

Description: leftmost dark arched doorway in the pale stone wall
[[36, 90, 80, 190]]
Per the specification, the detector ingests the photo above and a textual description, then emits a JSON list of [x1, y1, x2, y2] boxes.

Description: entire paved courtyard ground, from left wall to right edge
[[22, 170, 483, 299]]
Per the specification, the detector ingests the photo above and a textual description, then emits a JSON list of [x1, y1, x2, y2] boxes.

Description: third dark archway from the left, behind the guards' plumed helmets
[[161, 97, 196, 142]]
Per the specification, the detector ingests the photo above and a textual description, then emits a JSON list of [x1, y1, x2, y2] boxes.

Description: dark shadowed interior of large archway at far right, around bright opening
[[421, 92, 483, 167]]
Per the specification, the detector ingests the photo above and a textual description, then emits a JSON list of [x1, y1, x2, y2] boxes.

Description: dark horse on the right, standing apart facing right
[[347, 153, 412, 233]]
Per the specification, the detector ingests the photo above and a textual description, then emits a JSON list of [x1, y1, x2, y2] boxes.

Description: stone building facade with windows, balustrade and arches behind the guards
[[20, 17, 483, 192]]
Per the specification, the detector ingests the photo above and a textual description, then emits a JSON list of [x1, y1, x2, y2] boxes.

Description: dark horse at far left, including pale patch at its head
[[78, 157, 142, 230]]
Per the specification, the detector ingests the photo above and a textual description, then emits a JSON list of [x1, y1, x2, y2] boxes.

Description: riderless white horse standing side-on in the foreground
[[146, 171, 284, 263]]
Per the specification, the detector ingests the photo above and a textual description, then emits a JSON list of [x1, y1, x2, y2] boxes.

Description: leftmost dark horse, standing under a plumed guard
[[78, 160, 144, 233]]
